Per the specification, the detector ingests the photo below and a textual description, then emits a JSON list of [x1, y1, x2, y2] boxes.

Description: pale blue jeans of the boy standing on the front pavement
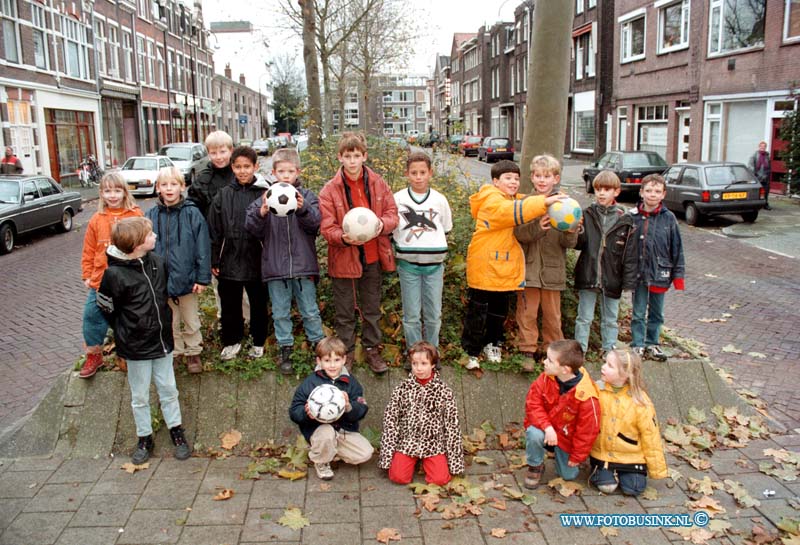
[[128, 352, 181, 437]]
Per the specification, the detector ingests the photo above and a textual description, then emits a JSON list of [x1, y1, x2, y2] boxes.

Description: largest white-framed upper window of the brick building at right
[[708, 0, 767, 55]]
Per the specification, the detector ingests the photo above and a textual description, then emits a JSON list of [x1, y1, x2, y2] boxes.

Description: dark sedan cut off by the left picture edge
[[0, 175, 83, 254]]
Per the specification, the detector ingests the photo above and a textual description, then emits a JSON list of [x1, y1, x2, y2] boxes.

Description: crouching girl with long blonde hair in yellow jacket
[[589, 350, 668, 496]]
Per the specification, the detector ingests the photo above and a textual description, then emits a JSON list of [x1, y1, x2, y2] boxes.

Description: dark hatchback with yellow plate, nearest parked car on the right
[[664, 162, 766, 225]]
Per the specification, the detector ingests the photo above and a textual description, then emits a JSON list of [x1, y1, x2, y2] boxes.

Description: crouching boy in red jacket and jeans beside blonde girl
[[525, 340, 600, 488]]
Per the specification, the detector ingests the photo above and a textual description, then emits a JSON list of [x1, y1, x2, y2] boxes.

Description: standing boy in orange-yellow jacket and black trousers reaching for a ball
[[461, 161, 565, 369]]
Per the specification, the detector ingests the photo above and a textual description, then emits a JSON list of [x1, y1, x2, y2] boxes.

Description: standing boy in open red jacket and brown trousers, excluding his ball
[[319, 132, 398, 373]]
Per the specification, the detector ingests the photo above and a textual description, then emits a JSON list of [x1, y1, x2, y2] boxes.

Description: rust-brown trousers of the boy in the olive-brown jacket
[[517, 288, 564, 352]]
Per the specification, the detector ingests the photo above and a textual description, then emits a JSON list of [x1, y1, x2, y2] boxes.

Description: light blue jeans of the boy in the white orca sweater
[[397, 265, 444, 347]]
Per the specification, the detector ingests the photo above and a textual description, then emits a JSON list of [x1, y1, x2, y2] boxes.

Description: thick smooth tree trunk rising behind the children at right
[[520, 1, 575, 193]]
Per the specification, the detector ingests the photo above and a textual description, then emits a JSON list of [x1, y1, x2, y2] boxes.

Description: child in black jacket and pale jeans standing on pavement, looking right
[[97, 218, 192, 464]]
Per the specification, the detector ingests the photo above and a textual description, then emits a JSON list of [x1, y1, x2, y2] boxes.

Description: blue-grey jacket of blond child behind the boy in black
[[145, 199, 211, 297]]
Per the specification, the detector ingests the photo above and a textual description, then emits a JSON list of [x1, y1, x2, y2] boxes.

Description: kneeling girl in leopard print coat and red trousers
[[378, 341, 464, 485]]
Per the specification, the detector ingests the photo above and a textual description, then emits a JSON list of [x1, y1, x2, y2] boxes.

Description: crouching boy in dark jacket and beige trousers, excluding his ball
[[289, 337, 374, 481]]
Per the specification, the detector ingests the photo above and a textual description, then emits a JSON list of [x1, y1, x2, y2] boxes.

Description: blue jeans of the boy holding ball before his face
[[267, 277, 325, 346]]
